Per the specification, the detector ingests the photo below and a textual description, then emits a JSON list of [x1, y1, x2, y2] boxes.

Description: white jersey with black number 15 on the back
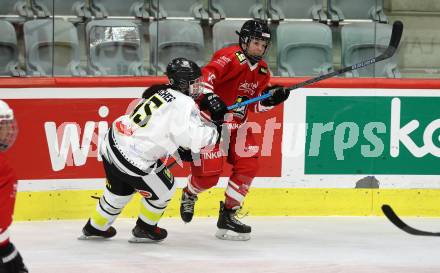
[[101, 88, 218, 171]]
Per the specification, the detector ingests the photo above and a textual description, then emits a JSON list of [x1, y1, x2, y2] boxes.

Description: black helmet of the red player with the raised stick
[[237, 19, 271, 63]]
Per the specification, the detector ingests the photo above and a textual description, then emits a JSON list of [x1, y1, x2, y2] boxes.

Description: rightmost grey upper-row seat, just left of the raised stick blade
[[327, 0, 388, 23]]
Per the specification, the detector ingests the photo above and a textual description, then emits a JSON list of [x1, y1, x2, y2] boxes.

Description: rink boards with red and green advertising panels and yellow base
[[0, 79, 440, 220]]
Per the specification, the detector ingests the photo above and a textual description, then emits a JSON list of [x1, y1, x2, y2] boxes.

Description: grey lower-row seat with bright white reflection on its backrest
[[86, 19, 148, 76]]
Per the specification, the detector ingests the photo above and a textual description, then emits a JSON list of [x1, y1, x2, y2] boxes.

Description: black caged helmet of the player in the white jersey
[[166, 58, 202, 98]]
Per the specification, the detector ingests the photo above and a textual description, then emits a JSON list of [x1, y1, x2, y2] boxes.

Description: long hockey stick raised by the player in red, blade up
[[228, 21, 403, 110]]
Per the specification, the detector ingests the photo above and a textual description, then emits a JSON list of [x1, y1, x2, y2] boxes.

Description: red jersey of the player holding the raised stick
[[202, 45, 272, 122]]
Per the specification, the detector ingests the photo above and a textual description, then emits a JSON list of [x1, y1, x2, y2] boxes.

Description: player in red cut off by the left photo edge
[[0, 100, 28, 273]]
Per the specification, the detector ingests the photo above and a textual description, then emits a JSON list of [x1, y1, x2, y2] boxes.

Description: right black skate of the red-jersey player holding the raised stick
[[215, 202, 251, 241]]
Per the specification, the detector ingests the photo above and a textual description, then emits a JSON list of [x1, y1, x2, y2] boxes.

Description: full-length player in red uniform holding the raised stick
[[180, 20, 289, 240]]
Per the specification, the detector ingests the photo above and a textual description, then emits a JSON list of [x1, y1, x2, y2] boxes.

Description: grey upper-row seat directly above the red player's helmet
[[208, 0, 267, 20]]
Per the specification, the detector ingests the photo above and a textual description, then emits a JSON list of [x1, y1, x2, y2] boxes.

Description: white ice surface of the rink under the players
[[11, 217, 440, 273]]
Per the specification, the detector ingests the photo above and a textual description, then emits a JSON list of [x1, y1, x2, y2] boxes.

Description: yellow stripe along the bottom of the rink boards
[[14, 188, 440, 220]]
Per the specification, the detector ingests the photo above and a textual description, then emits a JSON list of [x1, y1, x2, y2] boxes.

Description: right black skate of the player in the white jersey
[[128, 218, 168, 243]]
